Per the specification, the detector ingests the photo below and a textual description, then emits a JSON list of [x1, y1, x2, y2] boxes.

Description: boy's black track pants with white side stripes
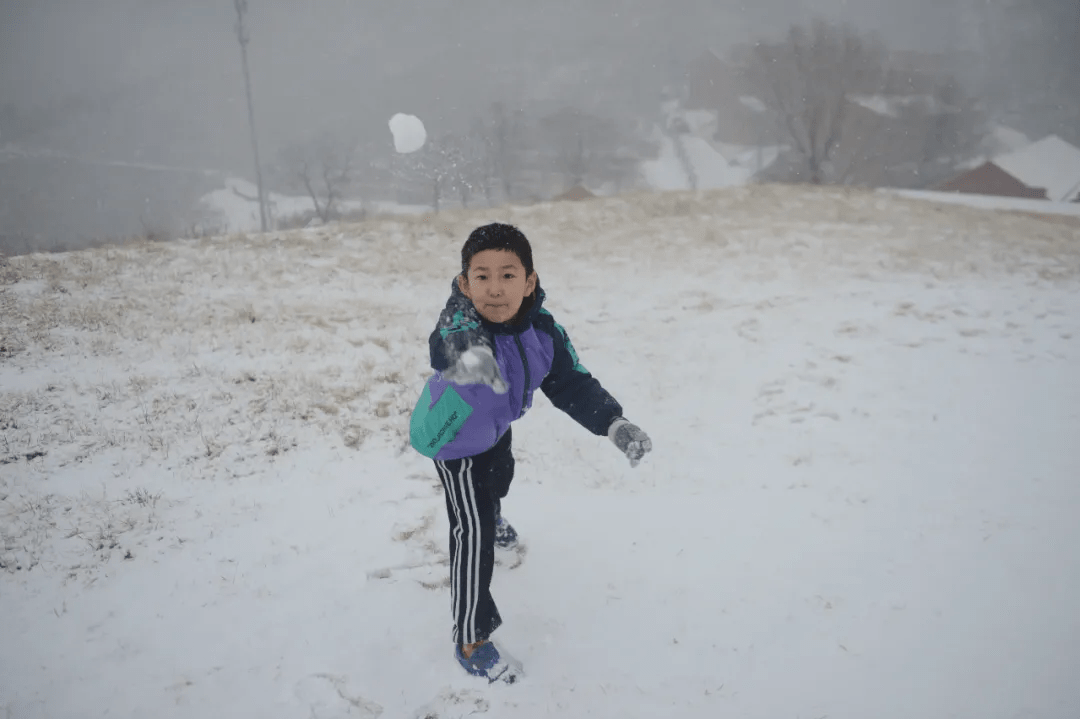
[[435, 429, 514, 645]]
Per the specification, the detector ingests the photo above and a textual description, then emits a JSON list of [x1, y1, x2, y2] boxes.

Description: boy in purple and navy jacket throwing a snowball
[[409, 223, 652, 683]]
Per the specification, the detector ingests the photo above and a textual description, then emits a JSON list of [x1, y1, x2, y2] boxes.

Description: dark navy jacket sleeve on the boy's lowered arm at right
[[535, 310, 622, 435]]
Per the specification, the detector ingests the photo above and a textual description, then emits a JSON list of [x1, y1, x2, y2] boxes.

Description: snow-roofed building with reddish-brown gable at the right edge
[[934, 135, 1080, 202]]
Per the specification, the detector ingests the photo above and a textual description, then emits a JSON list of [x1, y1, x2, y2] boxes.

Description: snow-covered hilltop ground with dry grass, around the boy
[[0, 186, 1080, 719]]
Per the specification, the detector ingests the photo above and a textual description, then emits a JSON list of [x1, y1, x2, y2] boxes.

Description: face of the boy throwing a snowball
[[458, 249, 537, 323]]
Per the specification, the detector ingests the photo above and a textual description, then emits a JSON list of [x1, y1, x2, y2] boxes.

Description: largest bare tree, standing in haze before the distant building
[[743, 19, 887, 184]]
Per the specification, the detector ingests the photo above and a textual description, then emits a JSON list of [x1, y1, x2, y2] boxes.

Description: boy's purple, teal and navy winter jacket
[[409, 281, 622, 460]]
